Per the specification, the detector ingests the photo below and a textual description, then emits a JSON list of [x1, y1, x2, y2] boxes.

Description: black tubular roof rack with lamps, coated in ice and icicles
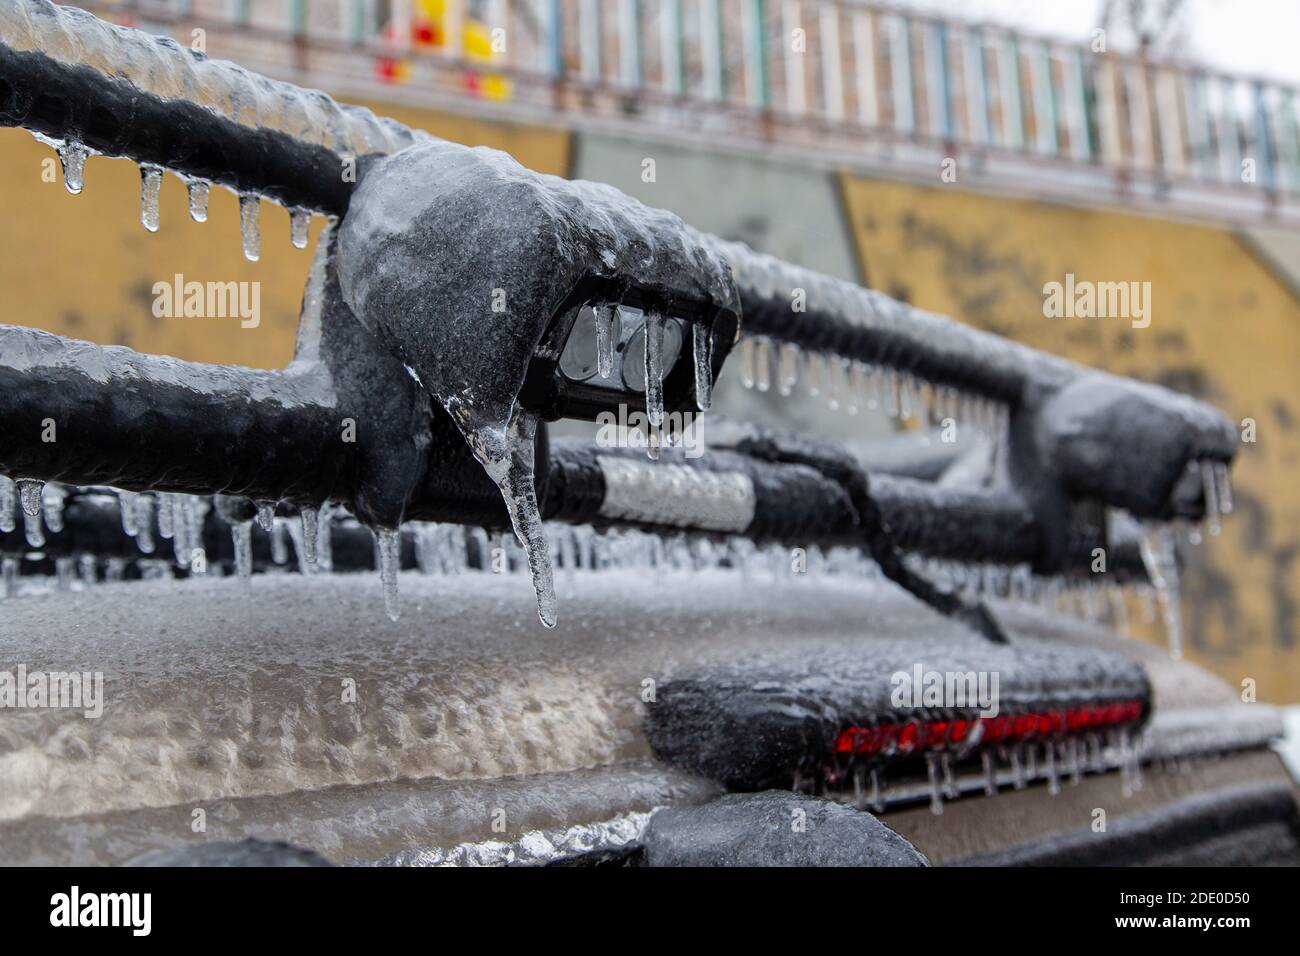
[[0, 0, 1235, 650]]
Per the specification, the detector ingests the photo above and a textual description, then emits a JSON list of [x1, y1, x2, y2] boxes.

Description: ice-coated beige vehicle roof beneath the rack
[[0, 570, 1196, 822]]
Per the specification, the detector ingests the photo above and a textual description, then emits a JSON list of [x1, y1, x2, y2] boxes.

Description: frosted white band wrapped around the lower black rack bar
[[595, 455, 755, 533]]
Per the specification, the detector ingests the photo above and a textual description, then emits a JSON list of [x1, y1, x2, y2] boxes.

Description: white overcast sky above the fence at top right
[[896, 0, 1300, 85]]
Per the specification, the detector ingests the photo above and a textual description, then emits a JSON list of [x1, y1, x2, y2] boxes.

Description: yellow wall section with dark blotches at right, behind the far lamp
[[842, 176, 1300, 701]]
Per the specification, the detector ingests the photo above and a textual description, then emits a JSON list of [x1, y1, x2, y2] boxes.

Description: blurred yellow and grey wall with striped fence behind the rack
[[10, 0, 1300, 701]]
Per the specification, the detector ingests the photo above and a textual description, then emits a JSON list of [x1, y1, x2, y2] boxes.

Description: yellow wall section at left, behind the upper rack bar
[[0, 94, 569, 368]]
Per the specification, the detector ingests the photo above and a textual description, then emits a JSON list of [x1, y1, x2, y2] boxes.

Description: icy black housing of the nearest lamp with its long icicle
[[338, 140, 738, 626]]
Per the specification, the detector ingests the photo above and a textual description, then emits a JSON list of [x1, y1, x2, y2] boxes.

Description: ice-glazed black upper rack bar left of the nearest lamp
[[0, 0, 425, 215]]
